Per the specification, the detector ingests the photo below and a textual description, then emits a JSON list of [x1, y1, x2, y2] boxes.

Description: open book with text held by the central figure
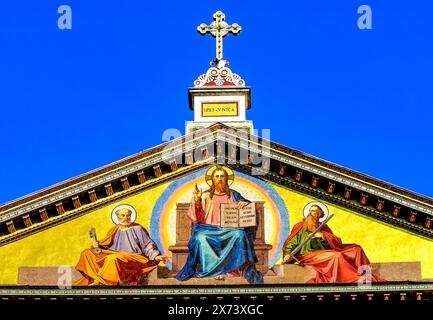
[[221, 203, 257, 228]]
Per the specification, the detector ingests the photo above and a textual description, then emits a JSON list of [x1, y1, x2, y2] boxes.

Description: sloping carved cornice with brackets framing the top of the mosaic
[[0, 123, 433, 245]]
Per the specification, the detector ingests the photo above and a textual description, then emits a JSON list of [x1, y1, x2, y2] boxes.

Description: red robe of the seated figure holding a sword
[[283, 221, 383, 283]]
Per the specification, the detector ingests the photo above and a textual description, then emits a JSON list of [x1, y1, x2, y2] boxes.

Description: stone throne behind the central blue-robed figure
[[168, 201, 272, 276]]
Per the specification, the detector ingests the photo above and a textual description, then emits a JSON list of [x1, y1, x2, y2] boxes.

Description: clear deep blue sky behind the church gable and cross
[[0, 0, 433, 203]]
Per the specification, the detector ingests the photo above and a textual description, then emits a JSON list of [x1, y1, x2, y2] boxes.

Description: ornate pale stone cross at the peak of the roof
[[197, 11, 242, 60]]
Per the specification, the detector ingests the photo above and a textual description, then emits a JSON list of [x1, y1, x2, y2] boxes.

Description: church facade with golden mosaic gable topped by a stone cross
[[0, 12, 433, 300]]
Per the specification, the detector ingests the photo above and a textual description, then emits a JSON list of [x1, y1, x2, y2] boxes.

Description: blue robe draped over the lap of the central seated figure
[[176, 190, 263, 284]]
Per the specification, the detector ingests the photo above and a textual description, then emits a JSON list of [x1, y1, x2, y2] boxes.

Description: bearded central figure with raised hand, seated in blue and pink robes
[[176, 165, 263, 284]]
